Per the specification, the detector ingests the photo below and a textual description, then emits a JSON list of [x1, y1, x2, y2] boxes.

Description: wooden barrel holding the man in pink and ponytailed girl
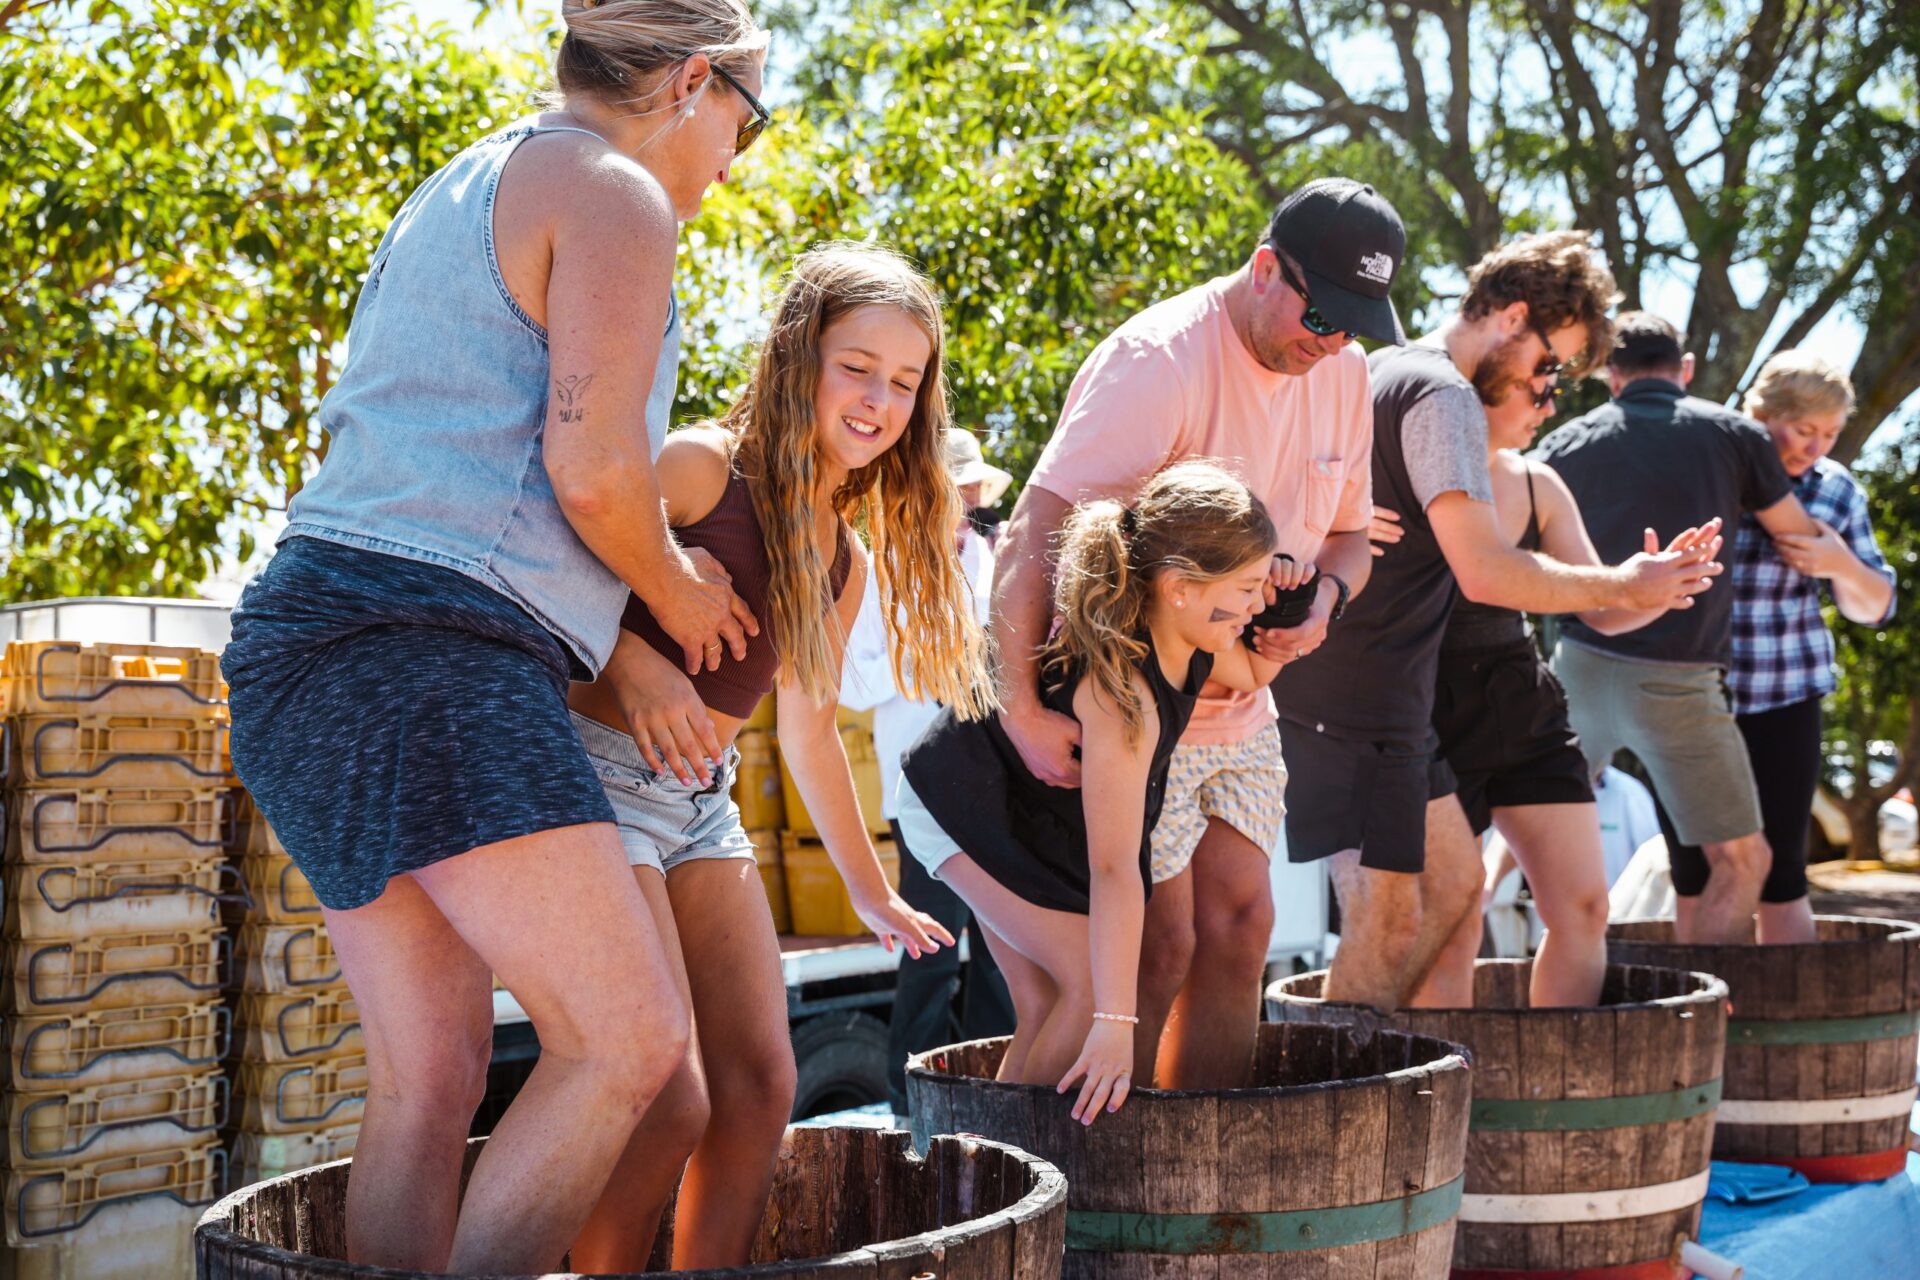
[[906, 1027, 1469, 1280]]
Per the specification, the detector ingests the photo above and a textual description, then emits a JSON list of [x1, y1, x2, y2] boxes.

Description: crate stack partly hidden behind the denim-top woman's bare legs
[[227, 789, 367, 1188]]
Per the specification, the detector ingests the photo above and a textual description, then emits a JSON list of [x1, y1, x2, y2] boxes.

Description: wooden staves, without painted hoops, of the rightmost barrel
[[1607, 915, 1920, 1180]]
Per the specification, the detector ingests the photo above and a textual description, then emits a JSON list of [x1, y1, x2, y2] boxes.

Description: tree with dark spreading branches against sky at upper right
[[1167, 0, 1920, 459]]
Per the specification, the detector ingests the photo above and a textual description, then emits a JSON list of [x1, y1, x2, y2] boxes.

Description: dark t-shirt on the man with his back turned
[[1536, 378, 1793, 666]]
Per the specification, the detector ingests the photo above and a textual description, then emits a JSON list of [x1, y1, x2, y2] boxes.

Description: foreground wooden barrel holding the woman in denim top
[[194, 1126, 1066, 1280]]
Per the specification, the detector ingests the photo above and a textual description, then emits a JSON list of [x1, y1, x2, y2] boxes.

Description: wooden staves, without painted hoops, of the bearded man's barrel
[[1269, 961, 1726, 1270]]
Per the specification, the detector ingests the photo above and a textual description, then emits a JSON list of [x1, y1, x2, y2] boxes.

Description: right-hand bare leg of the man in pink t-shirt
[[1154, 818, 1273, 1088]]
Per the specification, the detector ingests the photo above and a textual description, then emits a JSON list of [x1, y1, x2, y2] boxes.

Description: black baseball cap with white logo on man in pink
[[1267, 178, 1407, 345]]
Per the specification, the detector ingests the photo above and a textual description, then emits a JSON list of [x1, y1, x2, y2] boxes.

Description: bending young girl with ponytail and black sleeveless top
[[899, 462, 1277, 1125]]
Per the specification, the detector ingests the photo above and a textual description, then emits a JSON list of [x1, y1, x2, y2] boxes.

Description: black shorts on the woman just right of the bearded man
[[1434, 641, 1594, 835]]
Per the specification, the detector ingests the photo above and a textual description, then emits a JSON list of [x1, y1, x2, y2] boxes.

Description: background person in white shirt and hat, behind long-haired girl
[[841, 426, 1014, 1115]]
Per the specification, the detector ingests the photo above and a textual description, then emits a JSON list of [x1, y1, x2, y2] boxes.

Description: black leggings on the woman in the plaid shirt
[[1655, 697, 1820, 902]]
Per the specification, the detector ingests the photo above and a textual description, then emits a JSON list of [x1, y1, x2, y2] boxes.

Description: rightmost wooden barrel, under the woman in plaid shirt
[[1607, 915, 1920, 1182]]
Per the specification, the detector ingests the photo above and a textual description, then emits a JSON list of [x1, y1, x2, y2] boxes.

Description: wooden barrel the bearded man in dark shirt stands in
[[1267, 960, 1726, 1280]]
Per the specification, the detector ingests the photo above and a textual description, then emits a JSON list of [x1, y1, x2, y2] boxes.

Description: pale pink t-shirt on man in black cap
[[1027, 276, 1373, 743]]
